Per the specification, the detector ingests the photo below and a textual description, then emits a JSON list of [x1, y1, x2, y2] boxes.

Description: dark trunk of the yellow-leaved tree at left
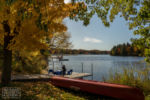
[[1, 21, 13, 85]]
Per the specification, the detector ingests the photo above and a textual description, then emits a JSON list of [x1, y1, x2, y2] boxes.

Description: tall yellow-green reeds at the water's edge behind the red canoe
[[104, 65, 150, 100]]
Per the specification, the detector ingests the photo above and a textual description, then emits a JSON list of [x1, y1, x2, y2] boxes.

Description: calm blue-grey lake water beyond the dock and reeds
[[49, 55, 146, 81]]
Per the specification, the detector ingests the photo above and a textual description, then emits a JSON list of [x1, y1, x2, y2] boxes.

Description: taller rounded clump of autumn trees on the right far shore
[[110, 43, 144, 56]]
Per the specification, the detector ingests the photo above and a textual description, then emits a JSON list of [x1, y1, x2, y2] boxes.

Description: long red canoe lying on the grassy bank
[[51, 76, 144, 100]]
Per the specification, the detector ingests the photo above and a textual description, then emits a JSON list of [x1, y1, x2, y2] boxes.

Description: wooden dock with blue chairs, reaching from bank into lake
[[11, 72, 91, 81]]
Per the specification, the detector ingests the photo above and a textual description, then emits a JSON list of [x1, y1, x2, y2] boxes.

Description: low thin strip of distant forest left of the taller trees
[[47, 49, 110, 54]]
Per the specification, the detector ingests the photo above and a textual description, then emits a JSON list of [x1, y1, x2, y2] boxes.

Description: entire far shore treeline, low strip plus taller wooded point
[[41, 43, 144, 56]]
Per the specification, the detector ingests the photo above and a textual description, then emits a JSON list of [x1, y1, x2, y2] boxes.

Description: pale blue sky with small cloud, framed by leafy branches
[[64, 0, 135, 50]]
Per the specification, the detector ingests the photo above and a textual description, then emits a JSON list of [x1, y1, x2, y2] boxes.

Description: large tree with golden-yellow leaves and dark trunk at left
[[0, 0, 79, 85]]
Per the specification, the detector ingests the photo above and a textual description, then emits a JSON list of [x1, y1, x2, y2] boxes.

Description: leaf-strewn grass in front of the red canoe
[[0, 82, 115, 100]]
